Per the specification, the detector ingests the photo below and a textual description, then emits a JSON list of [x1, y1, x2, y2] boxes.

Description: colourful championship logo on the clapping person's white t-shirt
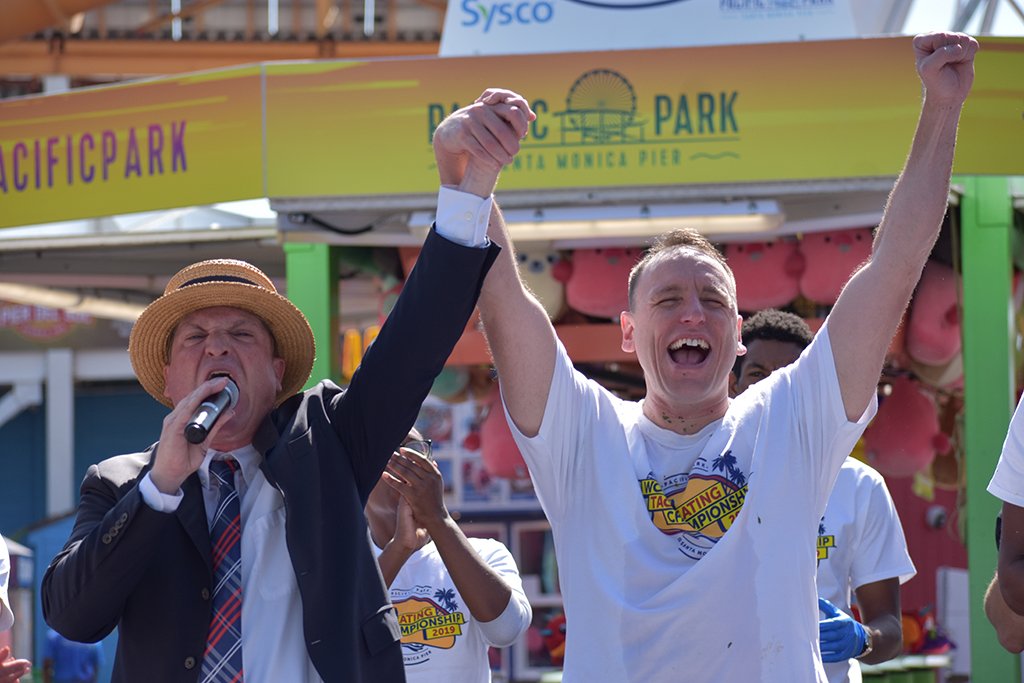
[[391, 586, 466, 664]]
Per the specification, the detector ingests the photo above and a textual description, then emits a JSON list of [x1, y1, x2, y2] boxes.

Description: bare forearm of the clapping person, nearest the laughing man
[[427, 516, 512, 622]]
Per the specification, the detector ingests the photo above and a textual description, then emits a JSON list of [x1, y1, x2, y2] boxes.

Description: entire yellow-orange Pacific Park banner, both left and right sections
[[0, 37, 1024, 227]]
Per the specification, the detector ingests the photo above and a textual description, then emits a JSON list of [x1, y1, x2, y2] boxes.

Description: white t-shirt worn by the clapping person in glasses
[[374, 538, 532, 683]]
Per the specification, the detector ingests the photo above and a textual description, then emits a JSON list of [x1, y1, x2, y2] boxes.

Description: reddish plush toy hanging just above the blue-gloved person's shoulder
[[864, 377, 949, 477]]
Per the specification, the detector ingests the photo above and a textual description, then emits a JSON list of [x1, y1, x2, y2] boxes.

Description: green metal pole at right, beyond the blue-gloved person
[[957, 176, 1021, 683]]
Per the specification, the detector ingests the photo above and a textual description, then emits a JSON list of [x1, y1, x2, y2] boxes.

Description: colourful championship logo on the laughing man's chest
[[640, 451, 746, 555]]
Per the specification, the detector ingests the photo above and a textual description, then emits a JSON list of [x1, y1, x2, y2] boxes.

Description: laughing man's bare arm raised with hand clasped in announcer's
[[434, 89, 555, 436]]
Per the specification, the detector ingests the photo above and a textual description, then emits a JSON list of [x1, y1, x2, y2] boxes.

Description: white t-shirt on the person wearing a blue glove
[[817, 458, 918, 683]]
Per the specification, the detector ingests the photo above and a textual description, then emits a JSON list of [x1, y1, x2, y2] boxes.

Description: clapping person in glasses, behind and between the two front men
[[366, 429, 532, 683]]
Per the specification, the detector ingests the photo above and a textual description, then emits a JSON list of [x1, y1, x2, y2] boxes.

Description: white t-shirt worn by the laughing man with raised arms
[[509, 325, 876, 683]]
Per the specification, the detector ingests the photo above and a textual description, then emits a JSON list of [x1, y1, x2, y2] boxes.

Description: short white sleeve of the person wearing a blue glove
[[850, 472, 918, 590]]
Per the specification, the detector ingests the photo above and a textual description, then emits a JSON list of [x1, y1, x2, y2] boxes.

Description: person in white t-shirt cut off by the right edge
[[985, 400, 1024, 652]]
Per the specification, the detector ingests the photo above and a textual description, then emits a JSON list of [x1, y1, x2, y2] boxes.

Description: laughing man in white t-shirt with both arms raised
[[434, 34, 977, 683]]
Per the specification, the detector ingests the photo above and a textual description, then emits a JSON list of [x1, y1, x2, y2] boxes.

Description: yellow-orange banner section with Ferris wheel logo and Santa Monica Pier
[[267, 38, 1024, 197]]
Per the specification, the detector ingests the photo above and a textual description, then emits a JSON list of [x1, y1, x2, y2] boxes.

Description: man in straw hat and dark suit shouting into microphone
[[42, 223, 498, 683]]
